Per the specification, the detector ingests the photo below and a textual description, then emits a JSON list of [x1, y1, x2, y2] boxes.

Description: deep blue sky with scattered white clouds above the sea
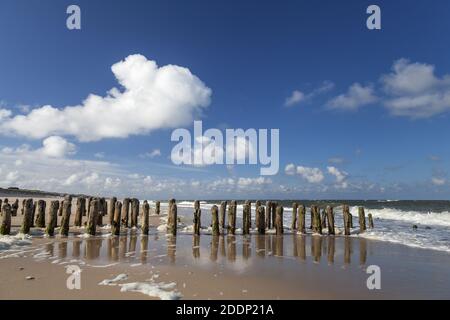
[[0, 0, 450, 199]]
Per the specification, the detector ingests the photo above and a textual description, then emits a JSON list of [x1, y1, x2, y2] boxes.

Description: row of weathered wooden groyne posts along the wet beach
[[0, 195, 374, 236]]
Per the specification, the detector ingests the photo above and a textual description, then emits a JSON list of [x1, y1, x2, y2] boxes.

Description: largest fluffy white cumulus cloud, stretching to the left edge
[[0, 54, 211, 142]]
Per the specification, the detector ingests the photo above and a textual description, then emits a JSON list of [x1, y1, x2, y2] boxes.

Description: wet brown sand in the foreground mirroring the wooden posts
[[0, 196, 450, 300]]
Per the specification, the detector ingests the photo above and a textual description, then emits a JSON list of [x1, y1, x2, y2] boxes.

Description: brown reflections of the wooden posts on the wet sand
[[43, 234, 373, 266]]
